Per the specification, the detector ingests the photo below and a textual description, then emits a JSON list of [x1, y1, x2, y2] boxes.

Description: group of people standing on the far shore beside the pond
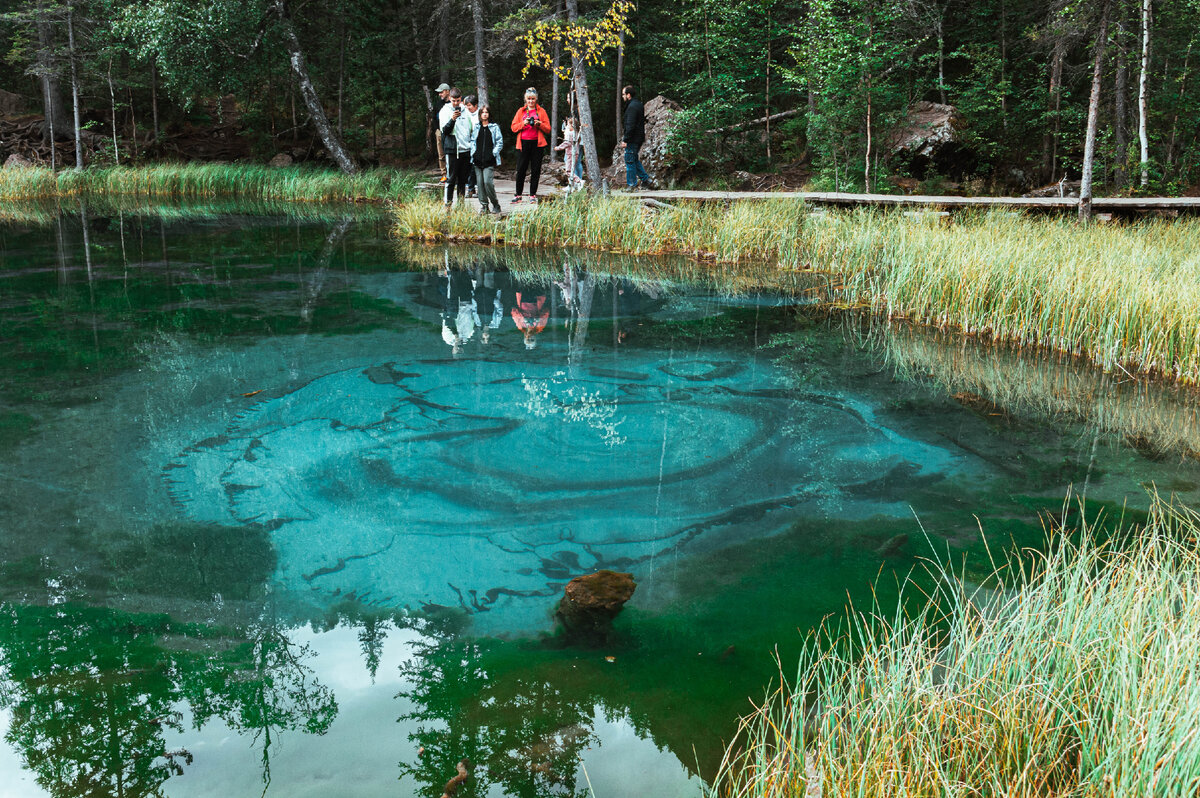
[[437, 83, 650, 214]]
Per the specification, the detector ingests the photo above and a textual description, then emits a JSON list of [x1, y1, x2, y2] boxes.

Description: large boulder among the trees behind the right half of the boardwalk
[[888, 101, 976, 179]]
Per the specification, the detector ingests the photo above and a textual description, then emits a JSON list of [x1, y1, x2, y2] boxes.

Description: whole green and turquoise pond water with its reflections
[[0, 208, 1200, 798]]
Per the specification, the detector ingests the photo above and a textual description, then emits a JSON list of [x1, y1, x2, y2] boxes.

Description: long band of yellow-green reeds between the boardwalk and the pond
[[396, 197, 1200, 384]]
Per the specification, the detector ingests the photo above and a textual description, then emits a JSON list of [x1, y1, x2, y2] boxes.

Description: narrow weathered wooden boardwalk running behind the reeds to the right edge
[[622, 190, 1200, 214]]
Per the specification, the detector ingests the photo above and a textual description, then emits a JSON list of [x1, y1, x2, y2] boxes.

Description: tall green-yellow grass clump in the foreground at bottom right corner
[[714, 499, 1200, 798]]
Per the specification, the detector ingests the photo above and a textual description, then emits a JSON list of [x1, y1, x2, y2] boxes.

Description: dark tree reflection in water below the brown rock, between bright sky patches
[[397, 614, 594, 798]]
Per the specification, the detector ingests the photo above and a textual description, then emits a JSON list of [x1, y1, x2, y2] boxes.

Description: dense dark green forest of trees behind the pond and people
[[0, 0, 1200, 194]]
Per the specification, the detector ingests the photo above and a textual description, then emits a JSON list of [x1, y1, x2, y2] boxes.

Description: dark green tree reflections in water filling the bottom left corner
[[0, 604, 337, 797]]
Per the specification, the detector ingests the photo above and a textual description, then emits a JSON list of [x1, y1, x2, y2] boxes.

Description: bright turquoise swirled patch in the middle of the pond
[[164, 352, 982, 634]]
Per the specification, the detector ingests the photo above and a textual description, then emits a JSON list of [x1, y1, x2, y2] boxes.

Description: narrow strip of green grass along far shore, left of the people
[[0, 163, 419, 203]]
